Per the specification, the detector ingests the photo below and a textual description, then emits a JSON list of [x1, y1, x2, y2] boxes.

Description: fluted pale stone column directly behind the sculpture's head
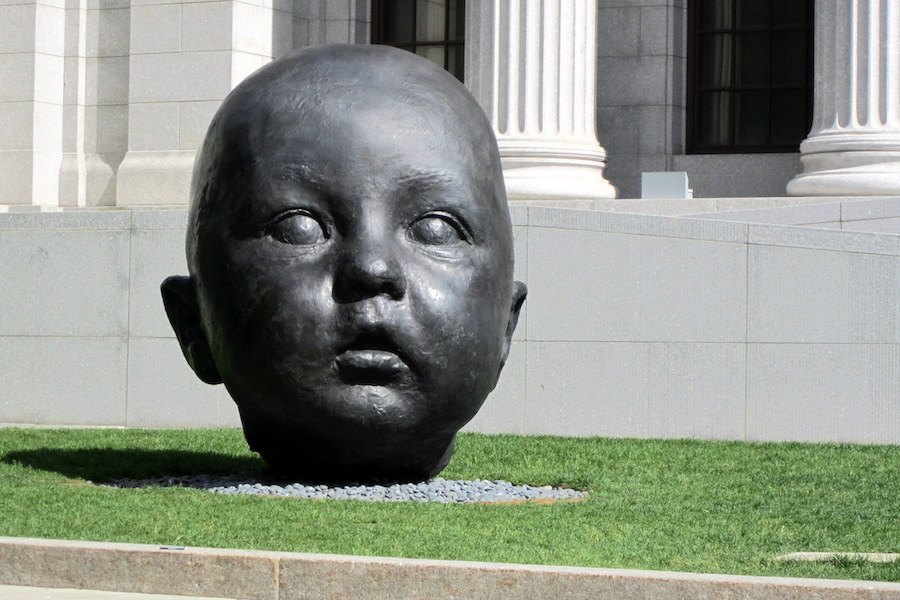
[[466, 0, 615, 200]]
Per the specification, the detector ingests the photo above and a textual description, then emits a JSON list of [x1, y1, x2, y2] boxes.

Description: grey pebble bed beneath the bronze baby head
[[103, 475, 587, 504]]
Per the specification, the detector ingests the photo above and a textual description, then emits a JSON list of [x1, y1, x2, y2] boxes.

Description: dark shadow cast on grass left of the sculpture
[[0, 448, 265, 482]]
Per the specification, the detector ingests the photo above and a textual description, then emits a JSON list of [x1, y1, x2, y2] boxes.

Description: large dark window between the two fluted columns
[[687, 0, 813, 153]]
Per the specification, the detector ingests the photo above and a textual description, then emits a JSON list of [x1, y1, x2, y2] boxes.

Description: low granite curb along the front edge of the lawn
[[0, 537, 900, 600]]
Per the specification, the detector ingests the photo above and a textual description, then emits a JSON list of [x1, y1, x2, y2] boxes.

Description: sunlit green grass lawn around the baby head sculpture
[[0, 429, 900, 581]]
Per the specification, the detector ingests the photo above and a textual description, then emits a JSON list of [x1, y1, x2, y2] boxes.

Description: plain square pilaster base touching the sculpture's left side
[[116, 150, 197, 206]]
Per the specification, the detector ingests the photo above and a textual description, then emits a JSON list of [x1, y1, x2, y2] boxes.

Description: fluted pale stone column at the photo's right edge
[[787, 0, 900, 196]]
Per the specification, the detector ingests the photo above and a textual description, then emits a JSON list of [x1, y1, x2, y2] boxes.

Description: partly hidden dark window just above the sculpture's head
[[372, 0, 466, 81]]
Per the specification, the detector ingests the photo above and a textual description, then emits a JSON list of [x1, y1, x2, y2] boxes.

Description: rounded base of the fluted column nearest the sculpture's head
[[498, 136, 616, 201]]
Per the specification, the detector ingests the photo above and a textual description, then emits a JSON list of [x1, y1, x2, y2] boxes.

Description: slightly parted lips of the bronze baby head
[[334, 336, 409, 385]]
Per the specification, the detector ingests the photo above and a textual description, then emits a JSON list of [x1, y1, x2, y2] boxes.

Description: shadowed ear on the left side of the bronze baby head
[[160, 275, 222, 384]]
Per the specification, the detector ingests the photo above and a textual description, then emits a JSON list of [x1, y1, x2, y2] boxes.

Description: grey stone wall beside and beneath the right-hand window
[[597, 0, 801, 198]]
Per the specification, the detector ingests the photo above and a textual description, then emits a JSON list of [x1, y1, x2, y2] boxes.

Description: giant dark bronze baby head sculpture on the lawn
[[162, 45, 526, 482]]
